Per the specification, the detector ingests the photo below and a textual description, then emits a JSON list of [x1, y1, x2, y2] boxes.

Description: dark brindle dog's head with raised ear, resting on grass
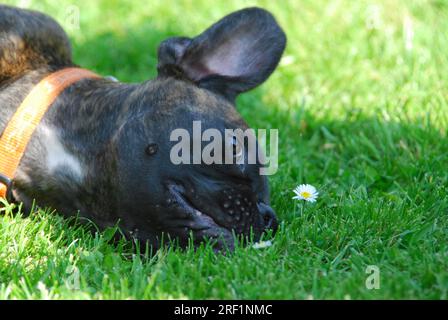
[[107, 8, 286, 248]]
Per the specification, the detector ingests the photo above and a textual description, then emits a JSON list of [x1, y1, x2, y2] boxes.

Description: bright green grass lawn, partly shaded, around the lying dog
[[0, 0, 448, 299]]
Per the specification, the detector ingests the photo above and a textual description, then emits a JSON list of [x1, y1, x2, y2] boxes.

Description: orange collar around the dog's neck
[[0, 68, 99, 200]]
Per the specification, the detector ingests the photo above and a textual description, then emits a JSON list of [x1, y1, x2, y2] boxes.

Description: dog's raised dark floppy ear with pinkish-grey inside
[[157, 8, 286, 99]]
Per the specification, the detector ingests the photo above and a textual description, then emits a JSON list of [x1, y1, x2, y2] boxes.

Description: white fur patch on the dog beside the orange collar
[[42, 127, 84, 181]]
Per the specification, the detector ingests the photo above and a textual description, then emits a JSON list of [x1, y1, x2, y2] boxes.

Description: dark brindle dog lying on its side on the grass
[[0, 5, 286, 248]]
